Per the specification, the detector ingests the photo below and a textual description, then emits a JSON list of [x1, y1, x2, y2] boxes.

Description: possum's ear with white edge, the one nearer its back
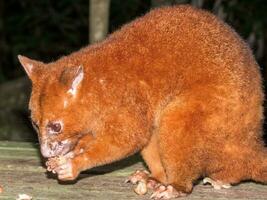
[[59, 66, 84, 96]]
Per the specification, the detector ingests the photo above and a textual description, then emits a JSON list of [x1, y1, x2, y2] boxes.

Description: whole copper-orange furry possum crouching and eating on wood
[[19, 6, 267, 199]]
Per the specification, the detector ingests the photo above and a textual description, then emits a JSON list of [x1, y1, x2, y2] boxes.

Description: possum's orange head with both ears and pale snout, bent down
[[18, 56, 93, 157]]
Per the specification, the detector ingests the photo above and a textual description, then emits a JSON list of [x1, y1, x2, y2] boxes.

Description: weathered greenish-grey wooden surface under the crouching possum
[[0, 142, 267, 200]]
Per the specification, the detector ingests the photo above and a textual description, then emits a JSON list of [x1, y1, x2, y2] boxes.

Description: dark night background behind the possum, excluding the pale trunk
[[0, 0, 267, 141]]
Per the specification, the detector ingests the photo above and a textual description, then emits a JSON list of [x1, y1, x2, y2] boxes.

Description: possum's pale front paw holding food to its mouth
[[46, 155, 80, 181]]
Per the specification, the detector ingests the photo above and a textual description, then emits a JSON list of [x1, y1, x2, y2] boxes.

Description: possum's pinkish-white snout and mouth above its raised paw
[[41, 140, 72, 158]]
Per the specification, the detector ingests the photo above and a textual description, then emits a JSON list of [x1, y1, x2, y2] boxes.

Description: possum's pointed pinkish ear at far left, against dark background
[[18, 55, 44, 80]]
